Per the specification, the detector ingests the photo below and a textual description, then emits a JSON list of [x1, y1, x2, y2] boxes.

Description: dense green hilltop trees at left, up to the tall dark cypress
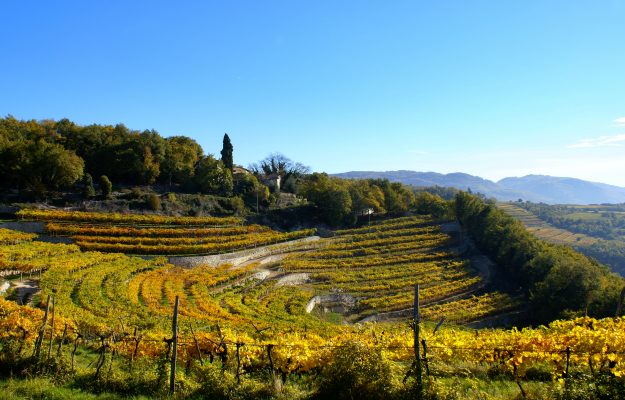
[[0, 116, 239, 198]]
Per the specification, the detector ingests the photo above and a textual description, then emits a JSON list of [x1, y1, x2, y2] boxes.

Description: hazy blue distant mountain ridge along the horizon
[[333, 170, 625, 204]]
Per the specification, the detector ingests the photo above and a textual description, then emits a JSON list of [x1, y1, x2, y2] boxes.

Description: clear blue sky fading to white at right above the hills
[[0, 0, 625, 186]]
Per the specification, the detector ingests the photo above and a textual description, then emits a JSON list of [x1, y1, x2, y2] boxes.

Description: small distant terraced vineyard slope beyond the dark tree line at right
[[497, 203, 597, 246]]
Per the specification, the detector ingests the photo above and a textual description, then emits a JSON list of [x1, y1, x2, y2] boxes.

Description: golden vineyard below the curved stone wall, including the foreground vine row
[[6, 217, 625, 396]]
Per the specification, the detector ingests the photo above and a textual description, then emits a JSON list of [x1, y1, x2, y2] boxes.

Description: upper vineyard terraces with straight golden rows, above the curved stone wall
[[18, 210, 315, 255]]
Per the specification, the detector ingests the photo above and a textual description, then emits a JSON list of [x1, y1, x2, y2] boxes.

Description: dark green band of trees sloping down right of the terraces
[[455, 192, 623, 323]]
